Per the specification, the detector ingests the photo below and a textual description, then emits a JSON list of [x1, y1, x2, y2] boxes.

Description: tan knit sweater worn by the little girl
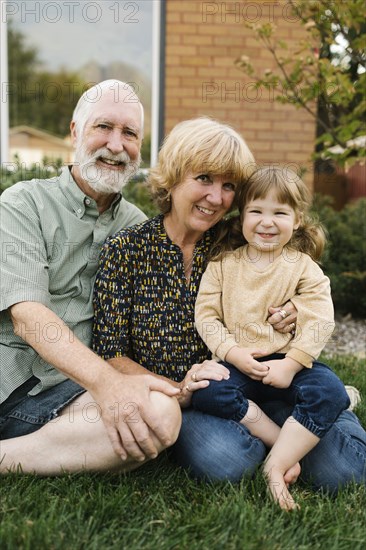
[[196, 246, 334, 367]]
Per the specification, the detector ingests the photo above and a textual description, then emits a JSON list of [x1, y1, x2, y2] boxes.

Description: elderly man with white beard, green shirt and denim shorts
[[0, 80, 181, 475]]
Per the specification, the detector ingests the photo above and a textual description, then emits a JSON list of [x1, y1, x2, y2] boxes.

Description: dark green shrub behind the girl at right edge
[[313, 195, 366, 317]]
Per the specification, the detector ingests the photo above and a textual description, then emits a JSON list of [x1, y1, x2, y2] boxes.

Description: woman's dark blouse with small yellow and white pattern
[[93, 215, 213, 381]]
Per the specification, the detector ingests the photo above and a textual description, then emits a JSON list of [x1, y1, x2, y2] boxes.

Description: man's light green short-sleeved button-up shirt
[[0, 168, 146, 402]]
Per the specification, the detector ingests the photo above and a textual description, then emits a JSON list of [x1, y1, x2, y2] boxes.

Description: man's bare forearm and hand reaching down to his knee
[[10, 302, 179, 460]]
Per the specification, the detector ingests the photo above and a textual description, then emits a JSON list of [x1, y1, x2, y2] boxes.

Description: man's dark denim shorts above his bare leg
[[0, 376, 85, 440]]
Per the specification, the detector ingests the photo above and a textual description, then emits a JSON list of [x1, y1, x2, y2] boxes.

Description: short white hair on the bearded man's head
[[72, 79, 144, 137]]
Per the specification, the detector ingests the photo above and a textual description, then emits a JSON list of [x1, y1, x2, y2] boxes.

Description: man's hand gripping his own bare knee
[[90, 367, 179, 462]]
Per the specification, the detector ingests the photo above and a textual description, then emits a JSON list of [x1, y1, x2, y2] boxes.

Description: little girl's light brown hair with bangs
[[211, 166, 326, 261]]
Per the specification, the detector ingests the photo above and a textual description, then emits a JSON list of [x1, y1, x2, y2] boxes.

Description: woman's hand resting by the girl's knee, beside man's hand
[[177, 360, 230, 409]]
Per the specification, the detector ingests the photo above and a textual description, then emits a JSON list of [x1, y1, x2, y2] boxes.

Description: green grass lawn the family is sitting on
[[0, 357, 366, 550]]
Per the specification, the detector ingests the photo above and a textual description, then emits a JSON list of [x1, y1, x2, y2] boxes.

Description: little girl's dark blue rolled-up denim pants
[[192, 354, 350, 438]]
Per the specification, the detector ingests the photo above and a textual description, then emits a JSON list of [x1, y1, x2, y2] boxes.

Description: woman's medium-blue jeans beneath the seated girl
[[170, 402, 366, 493]]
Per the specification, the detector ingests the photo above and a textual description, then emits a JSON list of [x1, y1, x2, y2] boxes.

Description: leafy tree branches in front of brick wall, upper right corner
[[236, 0, 366, 165]]
